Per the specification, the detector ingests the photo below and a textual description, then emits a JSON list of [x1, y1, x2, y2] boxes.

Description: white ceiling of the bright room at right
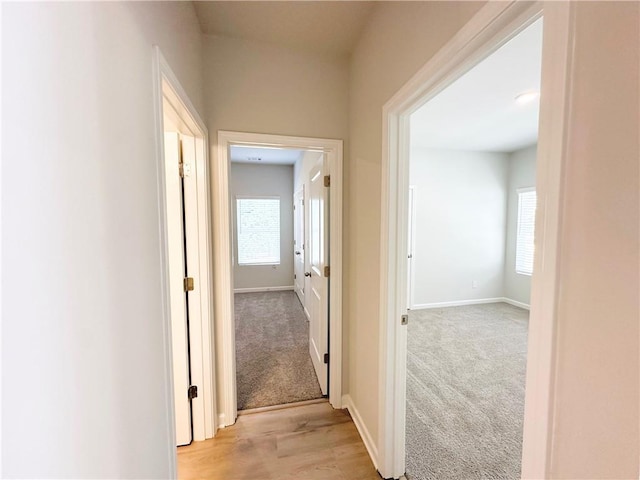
[[411, 19, 542, 152]]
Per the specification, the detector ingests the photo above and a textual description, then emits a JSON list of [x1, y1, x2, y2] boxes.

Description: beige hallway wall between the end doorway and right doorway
[[344, 2, 483, 448]]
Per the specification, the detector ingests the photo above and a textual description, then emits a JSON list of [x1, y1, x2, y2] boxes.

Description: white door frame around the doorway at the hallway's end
[[212, 130, 343, 427]]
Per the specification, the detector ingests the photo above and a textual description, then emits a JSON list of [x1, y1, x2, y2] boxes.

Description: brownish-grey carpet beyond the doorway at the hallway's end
[[235, 291, 322, 410]]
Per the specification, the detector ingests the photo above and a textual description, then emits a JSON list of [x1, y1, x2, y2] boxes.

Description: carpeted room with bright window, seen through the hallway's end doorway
[[230, 146, 326, 411]]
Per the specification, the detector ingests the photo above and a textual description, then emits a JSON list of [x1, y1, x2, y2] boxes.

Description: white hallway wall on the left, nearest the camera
[[2, 2, 203, 478]]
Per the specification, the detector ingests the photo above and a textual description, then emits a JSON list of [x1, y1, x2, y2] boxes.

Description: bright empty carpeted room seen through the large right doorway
[[406, 19, 543, 480]]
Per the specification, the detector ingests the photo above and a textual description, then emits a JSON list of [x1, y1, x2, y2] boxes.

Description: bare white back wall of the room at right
[[410, 148, 509, 308]]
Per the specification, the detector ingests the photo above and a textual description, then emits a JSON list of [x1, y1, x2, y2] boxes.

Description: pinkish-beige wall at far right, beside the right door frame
[[550, 2, 640, 478]]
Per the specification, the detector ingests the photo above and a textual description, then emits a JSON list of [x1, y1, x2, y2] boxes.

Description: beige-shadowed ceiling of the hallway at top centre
[[193, 1, 375, 55]]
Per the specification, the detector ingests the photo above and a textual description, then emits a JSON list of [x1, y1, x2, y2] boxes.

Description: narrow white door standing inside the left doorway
[[164, 132, 191, 446]]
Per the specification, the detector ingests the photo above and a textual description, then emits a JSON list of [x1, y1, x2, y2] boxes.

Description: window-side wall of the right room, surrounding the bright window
[[503, 145, 537, 305]]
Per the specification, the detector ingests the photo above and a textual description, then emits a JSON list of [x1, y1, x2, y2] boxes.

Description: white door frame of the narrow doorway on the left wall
[[153, 46, 217, 466]]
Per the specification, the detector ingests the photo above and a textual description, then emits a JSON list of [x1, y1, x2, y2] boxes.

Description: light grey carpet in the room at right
[[406, 303, 529, 480]]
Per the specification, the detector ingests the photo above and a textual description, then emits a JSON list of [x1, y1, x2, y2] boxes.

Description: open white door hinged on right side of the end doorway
[[306, 155, 329, 395]]
